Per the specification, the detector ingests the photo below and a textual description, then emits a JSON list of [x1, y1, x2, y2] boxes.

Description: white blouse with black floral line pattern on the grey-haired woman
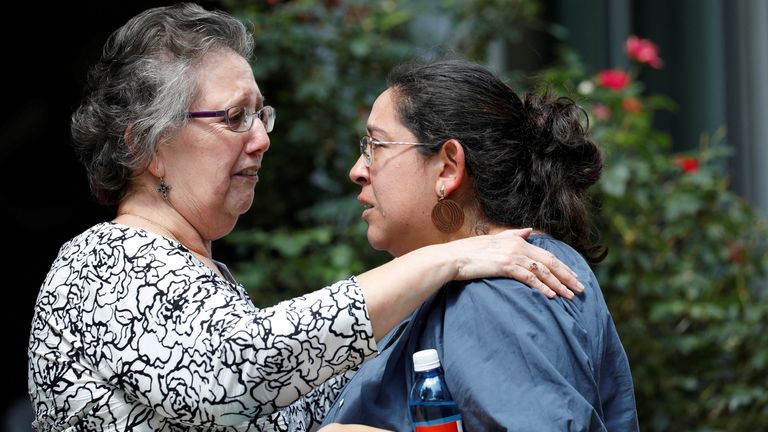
[[28, 223, 376, 432]]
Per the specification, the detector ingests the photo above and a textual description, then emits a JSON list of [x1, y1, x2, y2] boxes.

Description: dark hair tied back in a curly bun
[[388, 60, 606, 262]]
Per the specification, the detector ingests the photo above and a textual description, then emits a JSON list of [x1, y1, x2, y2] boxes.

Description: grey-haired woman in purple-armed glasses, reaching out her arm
[[28, 4, 579, 431]]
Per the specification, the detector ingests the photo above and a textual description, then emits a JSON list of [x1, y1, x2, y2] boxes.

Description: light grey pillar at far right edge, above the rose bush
[[725, 0, 768, 215]]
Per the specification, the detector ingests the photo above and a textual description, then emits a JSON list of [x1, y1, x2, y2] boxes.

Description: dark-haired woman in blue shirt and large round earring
[[316, 60, 638, 432]]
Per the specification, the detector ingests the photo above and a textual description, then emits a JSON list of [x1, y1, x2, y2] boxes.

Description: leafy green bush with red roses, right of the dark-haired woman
[[540, 38, 768, 431]]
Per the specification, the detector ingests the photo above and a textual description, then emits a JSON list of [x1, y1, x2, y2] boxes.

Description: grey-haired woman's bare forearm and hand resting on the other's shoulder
[[357, 229, 584, 340]]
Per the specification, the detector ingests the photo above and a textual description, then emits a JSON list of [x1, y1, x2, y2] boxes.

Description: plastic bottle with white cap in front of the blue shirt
[[409, 349, 463, 432]]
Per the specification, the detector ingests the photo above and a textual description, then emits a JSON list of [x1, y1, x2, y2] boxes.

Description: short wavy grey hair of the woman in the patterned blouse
[[71, 3, 253, 206]]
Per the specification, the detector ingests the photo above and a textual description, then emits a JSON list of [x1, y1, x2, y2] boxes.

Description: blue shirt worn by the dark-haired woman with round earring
[[323, 235, 639, 432]]
